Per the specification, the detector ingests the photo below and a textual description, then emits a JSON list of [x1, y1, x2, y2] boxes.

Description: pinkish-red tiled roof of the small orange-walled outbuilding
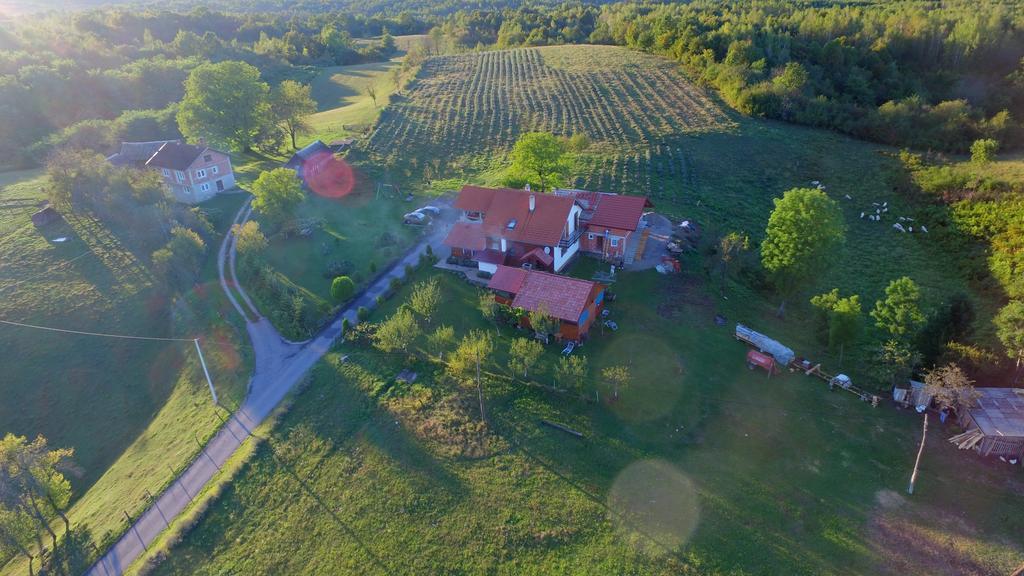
[[488, 266, 594, 322]]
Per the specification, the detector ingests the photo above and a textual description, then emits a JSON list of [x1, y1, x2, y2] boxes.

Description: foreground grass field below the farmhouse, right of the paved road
[[148, 261, 1024, 575]]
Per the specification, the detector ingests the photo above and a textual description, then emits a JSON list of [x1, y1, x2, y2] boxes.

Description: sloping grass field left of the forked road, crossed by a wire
[[0, 171, 248, 572]]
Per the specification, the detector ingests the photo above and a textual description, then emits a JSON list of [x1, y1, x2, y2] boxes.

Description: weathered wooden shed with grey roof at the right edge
[[962, 388, 1024, 458]]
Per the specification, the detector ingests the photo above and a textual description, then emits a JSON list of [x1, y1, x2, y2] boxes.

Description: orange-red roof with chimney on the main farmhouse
[[455, 186, 574, 246]]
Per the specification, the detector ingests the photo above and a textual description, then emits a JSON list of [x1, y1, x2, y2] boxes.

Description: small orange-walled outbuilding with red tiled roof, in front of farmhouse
[[487, 265, 604, 340]]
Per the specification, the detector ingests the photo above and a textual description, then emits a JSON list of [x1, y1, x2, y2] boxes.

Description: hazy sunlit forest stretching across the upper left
[[0, 9, 407, 164]]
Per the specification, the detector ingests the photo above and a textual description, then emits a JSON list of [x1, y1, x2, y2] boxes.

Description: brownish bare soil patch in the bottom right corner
[[867, 490, 1024, 576]]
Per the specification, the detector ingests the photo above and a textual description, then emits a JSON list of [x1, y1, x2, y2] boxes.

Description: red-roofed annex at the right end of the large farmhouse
[[555, 190, 653, 263]]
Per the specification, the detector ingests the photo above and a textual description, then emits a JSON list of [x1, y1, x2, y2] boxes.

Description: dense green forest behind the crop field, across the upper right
[[439, 0, 1024, 152]]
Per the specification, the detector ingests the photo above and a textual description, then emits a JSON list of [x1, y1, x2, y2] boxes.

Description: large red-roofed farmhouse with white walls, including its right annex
[[444, 186, 650, 273]]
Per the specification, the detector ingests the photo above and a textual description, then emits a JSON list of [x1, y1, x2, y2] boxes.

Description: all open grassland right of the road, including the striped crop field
[[148, 46, 1024, 575]]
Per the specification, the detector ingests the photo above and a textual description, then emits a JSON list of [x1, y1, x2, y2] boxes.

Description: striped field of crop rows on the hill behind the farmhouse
[[370, 46, 729, 198]]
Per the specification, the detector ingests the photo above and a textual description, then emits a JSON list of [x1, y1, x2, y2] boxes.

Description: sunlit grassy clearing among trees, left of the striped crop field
[[301, 58, 401, 143]]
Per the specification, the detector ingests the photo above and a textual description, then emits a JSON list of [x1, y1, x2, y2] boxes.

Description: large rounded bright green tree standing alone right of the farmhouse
[[761, 189, 846, 316]]
